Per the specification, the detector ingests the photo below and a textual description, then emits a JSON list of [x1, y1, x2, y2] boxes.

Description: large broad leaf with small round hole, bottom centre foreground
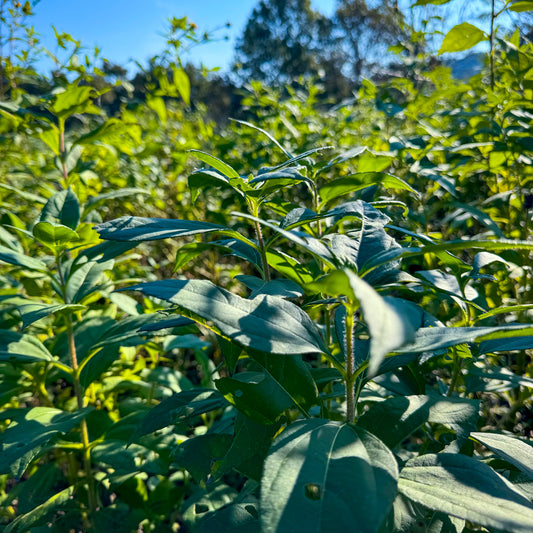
[[260, 419, 398, 533]]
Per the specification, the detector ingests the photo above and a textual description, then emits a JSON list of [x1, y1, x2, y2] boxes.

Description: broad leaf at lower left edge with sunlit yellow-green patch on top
[[0, 407, 93, 477]]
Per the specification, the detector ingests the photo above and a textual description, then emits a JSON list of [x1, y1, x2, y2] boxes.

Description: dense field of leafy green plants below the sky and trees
[[0, 0, 533, 533]]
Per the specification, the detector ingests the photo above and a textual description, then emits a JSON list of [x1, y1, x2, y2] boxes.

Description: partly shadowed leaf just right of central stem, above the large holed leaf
[[357, 395, 480, 448]]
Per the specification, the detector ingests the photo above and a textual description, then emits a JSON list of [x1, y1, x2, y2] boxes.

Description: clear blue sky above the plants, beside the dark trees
[[31, 0, 335, 69]]
